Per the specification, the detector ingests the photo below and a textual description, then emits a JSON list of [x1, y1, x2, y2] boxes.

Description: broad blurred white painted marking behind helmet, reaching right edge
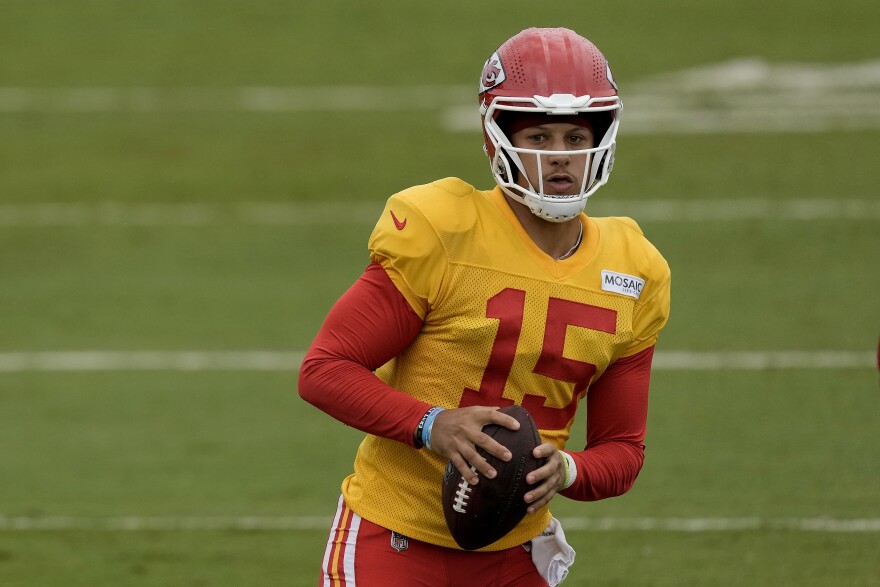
[[444, 59, 880, 136]]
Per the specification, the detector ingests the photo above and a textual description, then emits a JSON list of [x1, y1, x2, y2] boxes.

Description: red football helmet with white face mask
[[479, 28, 623, 222]]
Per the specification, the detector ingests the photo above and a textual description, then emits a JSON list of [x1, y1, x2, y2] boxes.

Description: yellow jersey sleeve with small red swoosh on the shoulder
[[369, 192, 446, 319]]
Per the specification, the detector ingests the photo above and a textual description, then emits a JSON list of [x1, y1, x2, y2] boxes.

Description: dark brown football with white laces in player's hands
[[443, 406, 547, 550]]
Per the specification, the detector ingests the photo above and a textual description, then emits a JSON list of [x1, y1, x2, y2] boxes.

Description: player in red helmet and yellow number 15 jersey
[[299, 28, 670, 587]]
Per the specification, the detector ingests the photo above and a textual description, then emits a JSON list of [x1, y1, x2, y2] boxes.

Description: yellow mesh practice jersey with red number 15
[[342, 178, 670, 550]]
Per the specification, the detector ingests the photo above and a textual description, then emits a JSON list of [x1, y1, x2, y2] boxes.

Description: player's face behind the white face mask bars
[[510, 122, 593, 194]]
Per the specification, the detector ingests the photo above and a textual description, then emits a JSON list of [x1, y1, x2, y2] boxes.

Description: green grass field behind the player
[[0, 0, 880, 587]]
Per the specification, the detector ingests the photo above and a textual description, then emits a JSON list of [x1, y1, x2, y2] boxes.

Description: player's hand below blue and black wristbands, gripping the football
[[431, 406, 519, 485]]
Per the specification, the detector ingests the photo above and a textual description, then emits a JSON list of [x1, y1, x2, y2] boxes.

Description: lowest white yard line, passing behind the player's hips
[[0, 515, 880, 533]]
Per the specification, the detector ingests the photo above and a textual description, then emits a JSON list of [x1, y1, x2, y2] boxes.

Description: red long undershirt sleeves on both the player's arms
[[299, 263, 654, 501]]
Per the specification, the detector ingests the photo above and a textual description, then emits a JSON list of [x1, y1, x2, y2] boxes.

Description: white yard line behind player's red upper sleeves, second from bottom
[[0, 350, 877, 373]]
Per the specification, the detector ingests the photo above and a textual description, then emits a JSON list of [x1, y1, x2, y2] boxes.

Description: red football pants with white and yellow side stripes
[[318, 497, 547, 587]]
